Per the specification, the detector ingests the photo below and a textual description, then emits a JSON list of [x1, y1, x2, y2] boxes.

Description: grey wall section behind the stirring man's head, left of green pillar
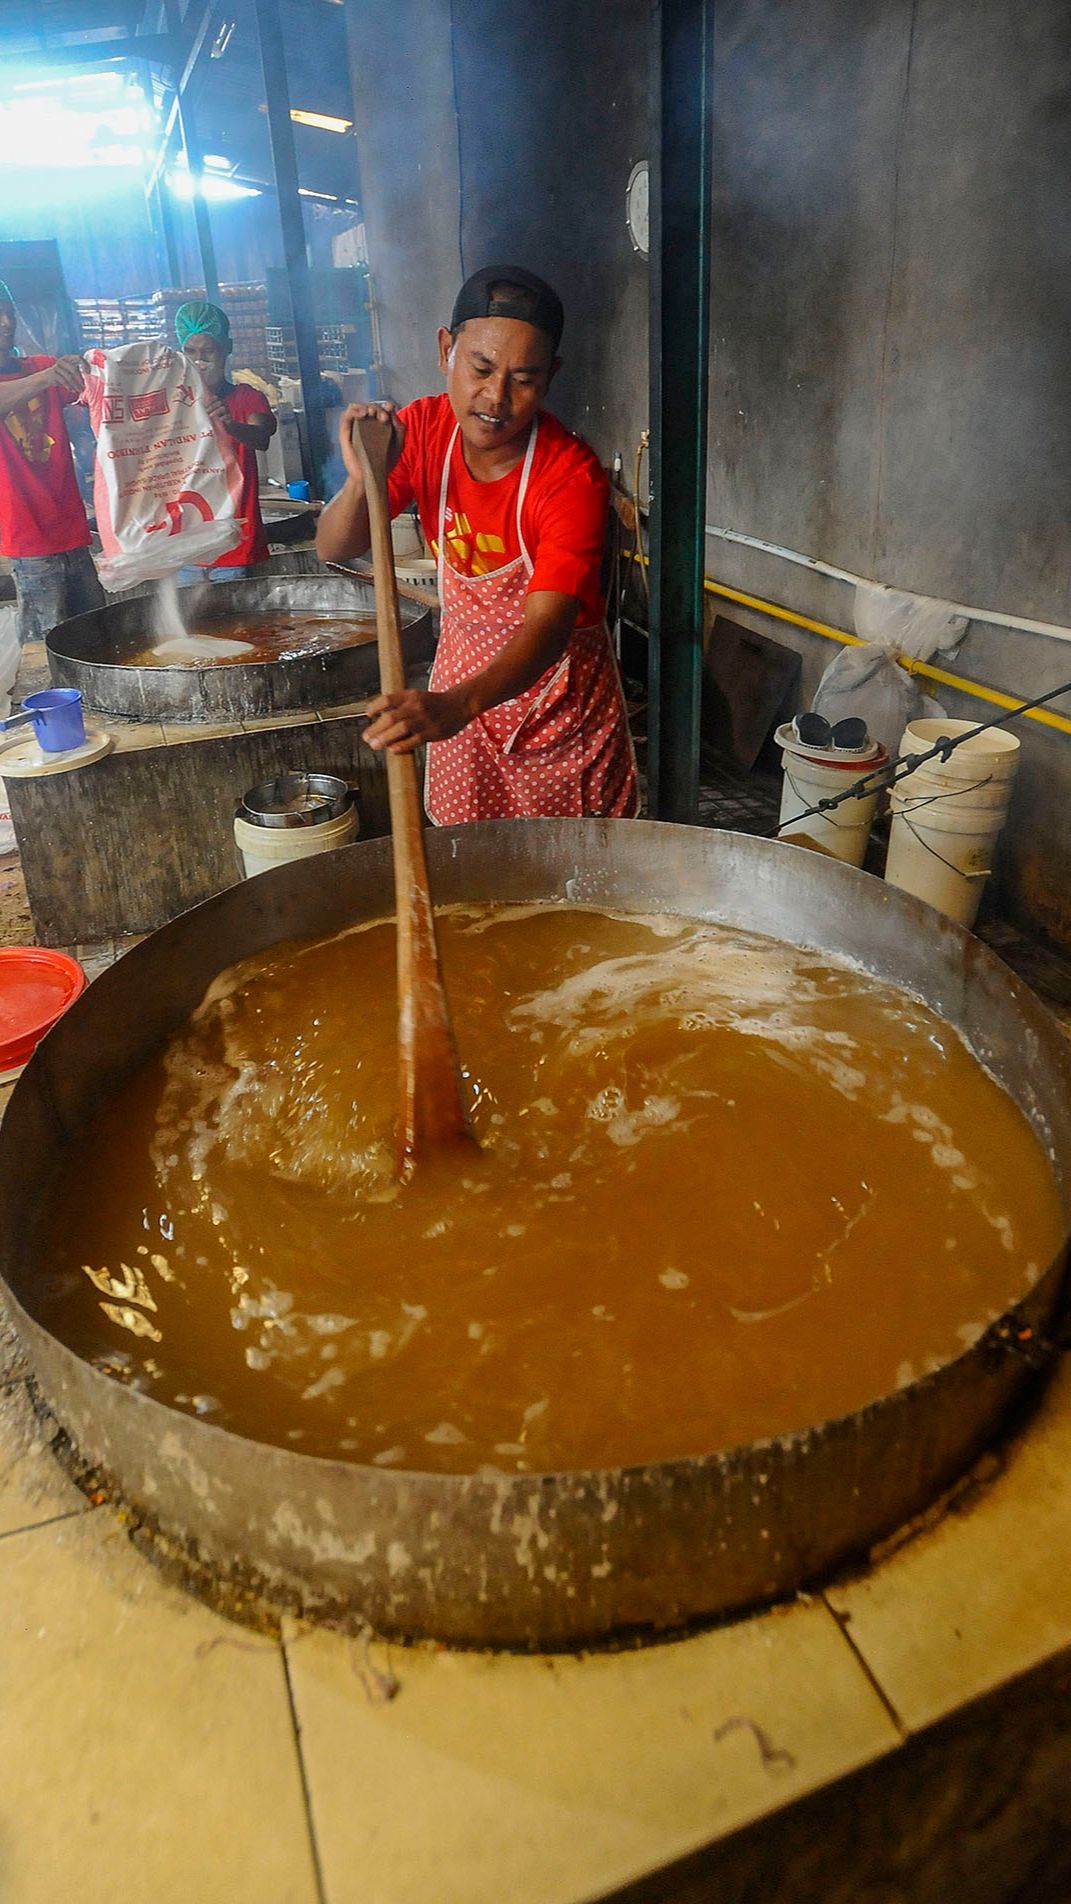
[[347, 0, 646, 461]]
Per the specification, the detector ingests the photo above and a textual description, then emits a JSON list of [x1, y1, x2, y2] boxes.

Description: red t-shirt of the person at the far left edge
[[0, 358, 90, 556]]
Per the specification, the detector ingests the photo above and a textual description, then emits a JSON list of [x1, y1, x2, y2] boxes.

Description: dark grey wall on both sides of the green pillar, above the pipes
[[347, 0, 1071, 621]]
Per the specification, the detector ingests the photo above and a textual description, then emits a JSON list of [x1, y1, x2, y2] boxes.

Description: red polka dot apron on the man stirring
[[425, 421, 638, 826]]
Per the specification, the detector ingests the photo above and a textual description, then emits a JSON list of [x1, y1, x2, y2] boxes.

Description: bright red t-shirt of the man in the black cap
[[389, 394, 610, 628]]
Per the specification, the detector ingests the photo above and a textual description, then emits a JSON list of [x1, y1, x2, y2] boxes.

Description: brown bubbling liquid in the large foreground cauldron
[[29, 906, 1060, 1472]]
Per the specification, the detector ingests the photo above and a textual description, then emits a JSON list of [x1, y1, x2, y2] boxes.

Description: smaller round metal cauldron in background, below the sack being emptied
[[46, 575, 434, 722]]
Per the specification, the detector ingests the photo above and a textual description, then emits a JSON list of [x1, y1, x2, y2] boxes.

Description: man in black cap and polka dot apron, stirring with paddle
[[316, 265, 638, 826]]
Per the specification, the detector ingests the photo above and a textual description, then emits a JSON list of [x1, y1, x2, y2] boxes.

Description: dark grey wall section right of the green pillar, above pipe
[[711, 0, 1071, 621]]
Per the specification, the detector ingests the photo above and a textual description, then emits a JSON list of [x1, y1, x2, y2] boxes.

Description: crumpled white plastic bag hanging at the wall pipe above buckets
[[812, 583, 966, 756]]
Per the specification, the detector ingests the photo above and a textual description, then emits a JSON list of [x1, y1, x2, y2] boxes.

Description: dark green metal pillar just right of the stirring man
[[648, 0, 715, 821]]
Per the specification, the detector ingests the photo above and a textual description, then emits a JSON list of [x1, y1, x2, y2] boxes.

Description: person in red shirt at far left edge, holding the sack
[[0, 280, 105, 642]]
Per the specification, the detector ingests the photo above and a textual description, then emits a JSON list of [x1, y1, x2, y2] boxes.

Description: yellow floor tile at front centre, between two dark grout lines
[[288, 1601, 899, 1904]]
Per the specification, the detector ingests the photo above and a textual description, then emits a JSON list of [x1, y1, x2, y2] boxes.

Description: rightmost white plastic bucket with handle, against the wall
[[884, 720, 1020, 927]]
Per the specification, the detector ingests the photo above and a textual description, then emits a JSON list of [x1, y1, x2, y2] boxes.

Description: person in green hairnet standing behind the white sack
[[175, 297, 278, 583]]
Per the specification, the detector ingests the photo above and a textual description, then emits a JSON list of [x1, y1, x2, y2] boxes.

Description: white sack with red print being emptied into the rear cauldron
[[86, 343, 244, 588]]
